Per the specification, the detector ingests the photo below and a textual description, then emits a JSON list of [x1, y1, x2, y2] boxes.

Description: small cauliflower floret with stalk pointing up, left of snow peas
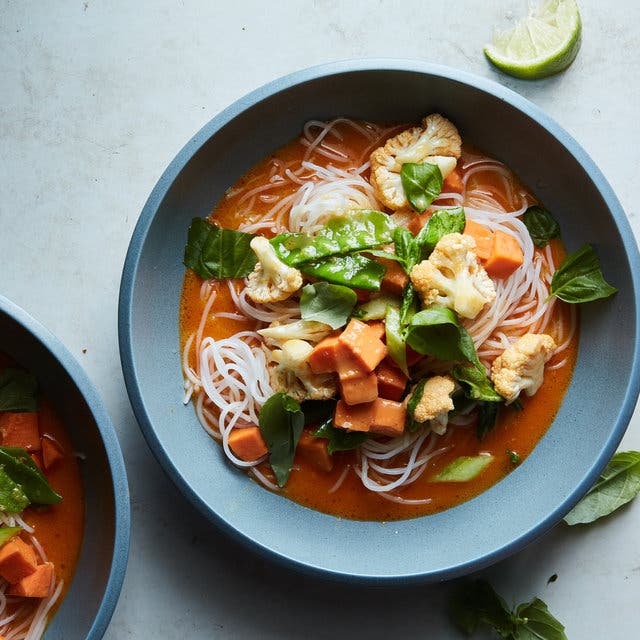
[[247, 236, 302, 304]]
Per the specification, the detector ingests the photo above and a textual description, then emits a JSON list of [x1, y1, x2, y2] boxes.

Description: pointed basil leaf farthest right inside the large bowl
[[549, 244, 617, 304]]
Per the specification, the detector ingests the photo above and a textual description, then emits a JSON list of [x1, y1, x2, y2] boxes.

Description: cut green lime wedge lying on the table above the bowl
[[484, 0, 582, 80]]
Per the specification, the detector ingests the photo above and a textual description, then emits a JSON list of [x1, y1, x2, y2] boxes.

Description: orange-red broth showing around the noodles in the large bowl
[[180, 124, 578, 521]]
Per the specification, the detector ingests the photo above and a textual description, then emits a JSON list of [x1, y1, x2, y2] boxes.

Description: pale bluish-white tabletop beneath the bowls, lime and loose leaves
[[0, 0, 640, 640]]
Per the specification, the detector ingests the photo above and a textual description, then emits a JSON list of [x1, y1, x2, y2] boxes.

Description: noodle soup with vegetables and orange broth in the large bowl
[[180, 116, 578, 520]]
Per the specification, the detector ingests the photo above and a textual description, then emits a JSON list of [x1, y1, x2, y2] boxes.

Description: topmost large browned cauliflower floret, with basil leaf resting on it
[[370, 113, 462, 211]]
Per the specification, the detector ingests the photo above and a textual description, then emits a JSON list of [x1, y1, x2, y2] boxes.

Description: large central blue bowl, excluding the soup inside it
[[119, 60, 640, 583]]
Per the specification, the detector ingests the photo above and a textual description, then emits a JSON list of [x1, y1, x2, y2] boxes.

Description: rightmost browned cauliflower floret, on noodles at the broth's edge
[[491, 333, 557, 404]]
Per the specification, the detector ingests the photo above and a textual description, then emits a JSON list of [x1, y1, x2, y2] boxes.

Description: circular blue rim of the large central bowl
[[118, 58, 640, 584]]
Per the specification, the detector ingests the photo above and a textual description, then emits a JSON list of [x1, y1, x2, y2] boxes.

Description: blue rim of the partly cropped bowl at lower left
[[0, 295, 131, 640]]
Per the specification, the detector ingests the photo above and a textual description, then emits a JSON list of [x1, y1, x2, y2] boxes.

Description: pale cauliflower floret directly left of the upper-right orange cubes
[[411, 233, 496, 318]]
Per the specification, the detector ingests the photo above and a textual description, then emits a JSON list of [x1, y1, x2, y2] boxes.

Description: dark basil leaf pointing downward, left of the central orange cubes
[[258, 391, 304, 487]]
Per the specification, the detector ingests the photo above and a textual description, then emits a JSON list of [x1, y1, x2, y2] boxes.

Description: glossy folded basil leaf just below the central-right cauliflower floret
[[407, 306, 478, 364]]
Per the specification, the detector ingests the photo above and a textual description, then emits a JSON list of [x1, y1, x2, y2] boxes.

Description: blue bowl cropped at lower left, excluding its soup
[[0, 296, 130, 640]]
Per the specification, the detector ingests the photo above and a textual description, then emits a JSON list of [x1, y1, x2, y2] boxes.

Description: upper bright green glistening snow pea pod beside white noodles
[[271, 209, 395, 267]]
